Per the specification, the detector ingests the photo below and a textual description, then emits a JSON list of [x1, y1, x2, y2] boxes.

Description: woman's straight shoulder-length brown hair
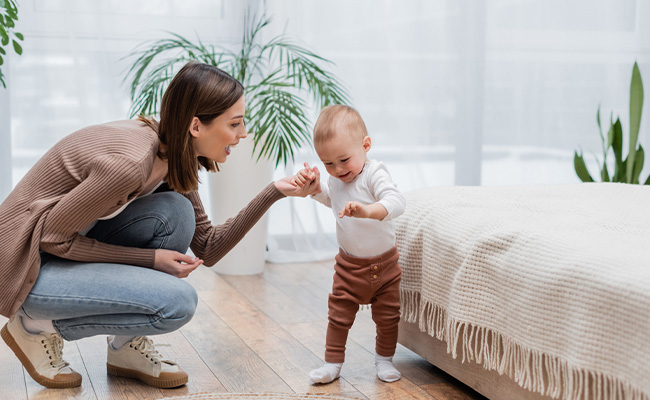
[[139, 61, 244, 193]]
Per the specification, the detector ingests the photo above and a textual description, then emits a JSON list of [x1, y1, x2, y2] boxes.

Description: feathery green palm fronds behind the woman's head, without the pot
[[125, 14, 349, 166]]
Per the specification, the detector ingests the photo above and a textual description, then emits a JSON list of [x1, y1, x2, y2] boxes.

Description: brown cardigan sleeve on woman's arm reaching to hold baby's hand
[[185, 183, 285, 267]]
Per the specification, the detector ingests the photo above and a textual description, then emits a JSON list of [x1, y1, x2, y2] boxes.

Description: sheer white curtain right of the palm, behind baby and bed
[[265, 0, 650, 261]]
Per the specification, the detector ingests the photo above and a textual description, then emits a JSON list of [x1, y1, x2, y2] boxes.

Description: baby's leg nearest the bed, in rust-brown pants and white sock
[[372, 266, 402, 382]]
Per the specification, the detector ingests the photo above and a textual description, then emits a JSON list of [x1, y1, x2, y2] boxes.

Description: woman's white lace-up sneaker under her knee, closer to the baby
[[106, 336, 188, 388]]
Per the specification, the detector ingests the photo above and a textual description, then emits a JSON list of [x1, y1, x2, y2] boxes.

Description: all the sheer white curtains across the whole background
[[0, 0, 650, 261]]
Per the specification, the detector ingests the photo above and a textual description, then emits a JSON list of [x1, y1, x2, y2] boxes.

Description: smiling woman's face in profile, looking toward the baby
[[190, 96, 247, 163]]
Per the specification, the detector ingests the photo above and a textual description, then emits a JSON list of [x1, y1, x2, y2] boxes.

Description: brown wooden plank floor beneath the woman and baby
[[0, 262, 482, 400]]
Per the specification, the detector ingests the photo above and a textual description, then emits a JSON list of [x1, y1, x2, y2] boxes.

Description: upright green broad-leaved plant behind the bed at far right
[[573, 62, 650, 185]]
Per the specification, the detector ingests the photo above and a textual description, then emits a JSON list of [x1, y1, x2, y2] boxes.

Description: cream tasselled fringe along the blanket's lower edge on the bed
[[401, 290, 650, 400]]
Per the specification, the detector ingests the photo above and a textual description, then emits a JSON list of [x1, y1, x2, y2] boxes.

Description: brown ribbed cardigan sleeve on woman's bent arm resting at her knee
[[40, 154, 155, 268]]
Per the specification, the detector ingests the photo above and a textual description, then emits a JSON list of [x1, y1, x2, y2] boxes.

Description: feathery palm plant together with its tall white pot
[[125, 13, 349, 274]]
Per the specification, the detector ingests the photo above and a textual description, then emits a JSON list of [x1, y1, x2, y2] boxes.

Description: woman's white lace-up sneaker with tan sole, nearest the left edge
[[1, 316, 81, 388]]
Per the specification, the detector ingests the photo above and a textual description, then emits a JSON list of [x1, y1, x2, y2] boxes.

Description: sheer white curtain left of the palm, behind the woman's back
[[0, 0, 249, 219]]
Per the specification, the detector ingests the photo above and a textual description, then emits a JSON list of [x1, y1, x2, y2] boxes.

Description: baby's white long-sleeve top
[[312, 160, 406, 257]]
